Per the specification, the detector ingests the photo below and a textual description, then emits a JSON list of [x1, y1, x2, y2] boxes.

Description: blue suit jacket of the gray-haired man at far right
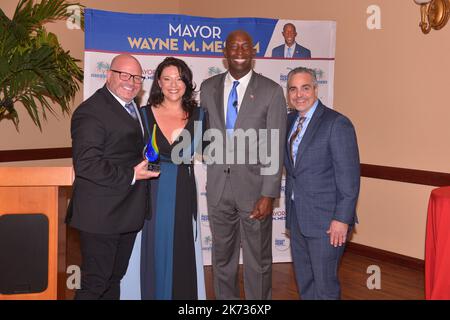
[[284, 100, 360, 237]]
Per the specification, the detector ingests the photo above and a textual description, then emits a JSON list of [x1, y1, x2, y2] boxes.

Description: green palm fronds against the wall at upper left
[[0, 0, 83, 130]]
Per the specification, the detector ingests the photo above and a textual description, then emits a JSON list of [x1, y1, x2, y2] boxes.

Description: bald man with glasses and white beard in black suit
[[67, 55, 158, 300]]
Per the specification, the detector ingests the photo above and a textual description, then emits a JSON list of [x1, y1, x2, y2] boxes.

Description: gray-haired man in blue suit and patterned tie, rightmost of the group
[[284, 67, 360, 300]]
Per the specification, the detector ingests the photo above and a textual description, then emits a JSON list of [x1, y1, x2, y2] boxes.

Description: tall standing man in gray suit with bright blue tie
[[200, 30, 286, 299]]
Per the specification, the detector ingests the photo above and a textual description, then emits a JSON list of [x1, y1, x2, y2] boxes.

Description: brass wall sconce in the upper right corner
[[414, 0, 450, 34]]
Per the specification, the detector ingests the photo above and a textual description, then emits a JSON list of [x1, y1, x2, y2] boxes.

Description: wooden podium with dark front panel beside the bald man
[[0, 167, 74, 300]]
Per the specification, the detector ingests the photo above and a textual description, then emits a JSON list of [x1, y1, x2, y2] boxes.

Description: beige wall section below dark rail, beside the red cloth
[[352, 178, 433, 259]]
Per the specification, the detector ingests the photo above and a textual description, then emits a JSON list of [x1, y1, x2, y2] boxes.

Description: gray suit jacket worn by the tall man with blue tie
[[200, 72, 287, 211]]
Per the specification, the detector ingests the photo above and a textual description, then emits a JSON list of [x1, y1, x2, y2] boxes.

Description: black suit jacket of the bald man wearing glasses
[[67, 86, 150, 234]]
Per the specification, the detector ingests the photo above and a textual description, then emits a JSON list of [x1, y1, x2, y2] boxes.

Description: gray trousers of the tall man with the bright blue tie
[[208, 179, 272, 300]]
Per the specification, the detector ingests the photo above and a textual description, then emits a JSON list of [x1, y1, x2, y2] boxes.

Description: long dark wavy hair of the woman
[[147, 57, 198, 119]]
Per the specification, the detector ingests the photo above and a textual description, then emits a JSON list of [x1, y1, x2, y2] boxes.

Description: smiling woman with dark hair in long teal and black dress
[[121, 57, 205, 300]]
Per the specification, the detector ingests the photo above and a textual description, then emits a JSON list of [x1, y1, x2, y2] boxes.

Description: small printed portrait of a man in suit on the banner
[[272, 23, 311, 59]]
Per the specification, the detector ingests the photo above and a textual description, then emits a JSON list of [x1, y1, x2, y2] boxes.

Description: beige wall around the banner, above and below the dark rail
[[0, 0, 450, 258]]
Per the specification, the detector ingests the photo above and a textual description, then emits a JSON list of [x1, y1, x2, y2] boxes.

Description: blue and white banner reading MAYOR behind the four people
[[84, 9, 336, 265]]
